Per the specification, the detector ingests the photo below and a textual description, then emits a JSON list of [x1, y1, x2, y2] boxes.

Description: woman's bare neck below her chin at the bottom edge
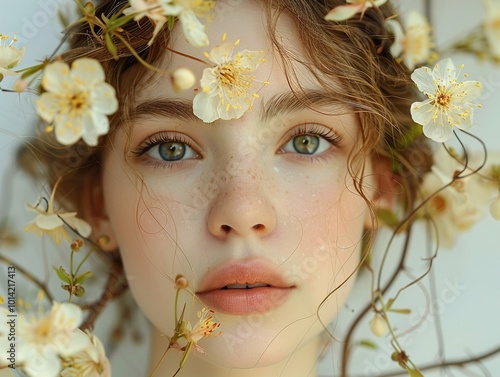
[[148, 329, 318, 377]]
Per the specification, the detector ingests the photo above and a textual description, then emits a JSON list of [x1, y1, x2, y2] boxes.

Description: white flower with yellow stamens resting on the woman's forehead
[[193, 42, 264, 123]]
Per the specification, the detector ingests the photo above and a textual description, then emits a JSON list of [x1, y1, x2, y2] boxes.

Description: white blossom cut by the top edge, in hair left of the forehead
[[123, 0, 214, 47]]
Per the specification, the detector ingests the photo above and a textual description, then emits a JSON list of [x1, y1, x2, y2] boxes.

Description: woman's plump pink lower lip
[[197, 287, 292, 315]]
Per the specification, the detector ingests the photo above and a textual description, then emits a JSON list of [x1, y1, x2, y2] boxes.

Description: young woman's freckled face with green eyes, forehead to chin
[[103, 1, 376, 367]]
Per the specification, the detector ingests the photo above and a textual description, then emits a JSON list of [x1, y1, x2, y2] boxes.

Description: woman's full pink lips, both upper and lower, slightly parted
[[196, 259, 295, 315]]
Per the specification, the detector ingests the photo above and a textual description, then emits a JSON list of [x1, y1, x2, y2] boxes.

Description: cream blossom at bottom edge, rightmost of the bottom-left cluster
[[61, 329, 111, 377]]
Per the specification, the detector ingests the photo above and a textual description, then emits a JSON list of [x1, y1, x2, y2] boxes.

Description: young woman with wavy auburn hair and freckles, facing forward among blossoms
[[1, 0, 498, 377]]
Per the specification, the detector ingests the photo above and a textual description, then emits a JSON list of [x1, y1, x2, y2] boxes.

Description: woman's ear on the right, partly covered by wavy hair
[[365, 155, 400, 229]]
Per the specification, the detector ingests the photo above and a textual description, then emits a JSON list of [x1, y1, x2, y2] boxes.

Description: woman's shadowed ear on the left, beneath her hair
[[82, 172, 118, 252]]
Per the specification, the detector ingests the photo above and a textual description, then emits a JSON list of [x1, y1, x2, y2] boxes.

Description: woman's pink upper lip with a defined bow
[[196, 259, 294, 293]]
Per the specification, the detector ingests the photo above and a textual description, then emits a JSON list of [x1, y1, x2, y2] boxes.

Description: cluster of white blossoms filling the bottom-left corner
[[0, 302, 111, 377]]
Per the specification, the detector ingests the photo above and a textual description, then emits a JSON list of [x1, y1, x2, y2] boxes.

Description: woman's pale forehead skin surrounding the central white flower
[[139, 0, 318, 102]]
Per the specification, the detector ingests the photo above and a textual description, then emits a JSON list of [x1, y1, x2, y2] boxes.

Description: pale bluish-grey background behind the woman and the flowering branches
[[0, 0, 500, 377]]
